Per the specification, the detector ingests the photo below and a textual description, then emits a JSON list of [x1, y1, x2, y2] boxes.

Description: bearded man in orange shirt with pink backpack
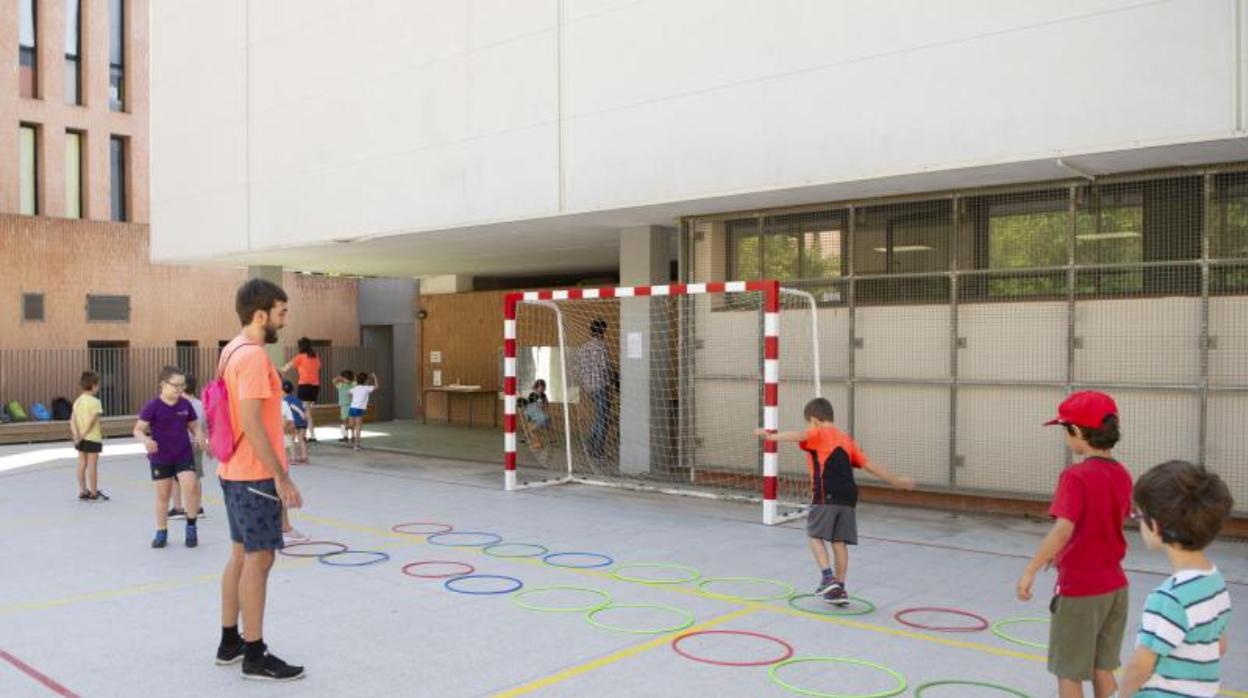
[[217, 278, 303, 681]]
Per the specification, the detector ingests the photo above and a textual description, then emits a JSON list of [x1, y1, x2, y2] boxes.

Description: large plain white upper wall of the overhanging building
[[151, 0, 1238, 258]]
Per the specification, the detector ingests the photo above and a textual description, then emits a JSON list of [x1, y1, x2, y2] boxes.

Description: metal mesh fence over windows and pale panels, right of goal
[[683, 167, 1248, 512]]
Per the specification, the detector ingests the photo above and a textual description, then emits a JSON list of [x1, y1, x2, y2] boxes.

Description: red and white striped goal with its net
[[504, 281, 820, 523]]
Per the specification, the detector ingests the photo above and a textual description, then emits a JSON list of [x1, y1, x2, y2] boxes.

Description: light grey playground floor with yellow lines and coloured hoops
[[0, 439, 1248, 698]]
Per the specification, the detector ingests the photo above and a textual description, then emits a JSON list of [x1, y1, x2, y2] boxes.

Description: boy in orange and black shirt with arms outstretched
[[754, 397, 915, 606]]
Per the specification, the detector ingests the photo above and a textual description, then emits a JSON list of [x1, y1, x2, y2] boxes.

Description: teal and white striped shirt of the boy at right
[[1134, 568, 1231, 698]]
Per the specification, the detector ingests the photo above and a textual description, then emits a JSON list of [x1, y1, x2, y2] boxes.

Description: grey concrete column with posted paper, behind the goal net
[[619, 226, 675, 473]]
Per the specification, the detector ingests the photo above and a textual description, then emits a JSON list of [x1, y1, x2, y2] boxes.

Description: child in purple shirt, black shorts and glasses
[[134, 366, 207, 548]]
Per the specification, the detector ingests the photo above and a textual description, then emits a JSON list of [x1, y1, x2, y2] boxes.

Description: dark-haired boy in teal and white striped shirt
[[1122, 461, 1233, 698]]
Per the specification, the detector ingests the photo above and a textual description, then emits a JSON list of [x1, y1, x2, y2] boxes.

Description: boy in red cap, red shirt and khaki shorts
[[1017, 391, 1131, 698]]
